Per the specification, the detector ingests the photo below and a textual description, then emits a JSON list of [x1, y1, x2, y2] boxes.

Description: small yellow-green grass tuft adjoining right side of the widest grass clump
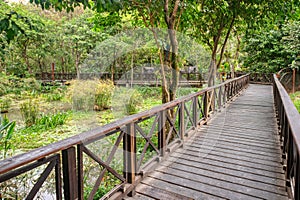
[[95, 80, 115, 110]]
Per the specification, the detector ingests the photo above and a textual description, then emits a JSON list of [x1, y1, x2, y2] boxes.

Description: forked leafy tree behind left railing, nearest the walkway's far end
[[184, 0, 299, 86]]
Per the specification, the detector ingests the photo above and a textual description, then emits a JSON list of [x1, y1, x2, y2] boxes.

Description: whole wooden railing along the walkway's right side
[[273, 75, 300, 199]]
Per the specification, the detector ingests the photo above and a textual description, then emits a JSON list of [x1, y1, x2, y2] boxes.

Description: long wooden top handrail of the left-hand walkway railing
[[0, 74, 248, 174]]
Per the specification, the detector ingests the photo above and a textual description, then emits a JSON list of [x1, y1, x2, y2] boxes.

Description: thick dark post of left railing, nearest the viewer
[[62, 147, 79, 200]]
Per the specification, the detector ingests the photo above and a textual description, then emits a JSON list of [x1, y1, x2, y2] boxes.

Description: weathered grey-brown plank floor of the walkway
[[126, 85, 288, 200]]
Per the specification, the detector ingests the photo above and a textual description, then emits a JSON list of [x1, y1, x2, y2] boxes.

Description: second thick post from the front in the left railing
[[123, 122, 136, 196]]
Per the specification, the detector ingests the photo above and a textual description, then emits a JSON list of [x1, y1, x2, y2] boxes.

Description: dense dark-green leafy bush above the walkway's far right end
[[244, 18, 300, 73]]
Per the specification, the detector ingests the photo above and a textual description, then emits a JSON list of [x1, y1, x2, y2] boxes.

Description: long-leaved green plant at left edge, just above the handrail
[[0, 116, 16, 159]]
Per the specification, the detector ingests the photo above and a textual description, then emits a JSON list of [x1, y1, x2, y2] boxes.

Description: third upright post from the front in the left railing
[[158, 110, 166, 157]]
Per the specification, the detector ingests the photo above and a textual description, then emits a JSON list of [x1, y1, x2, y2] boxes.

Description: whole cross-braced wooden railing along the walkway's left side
[[0, 75, 249, 199]]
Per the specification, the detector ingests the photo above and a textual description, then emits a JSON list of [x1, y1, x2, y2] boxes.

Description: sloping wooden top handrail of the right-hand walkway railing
[[273, 74, 300, 152]]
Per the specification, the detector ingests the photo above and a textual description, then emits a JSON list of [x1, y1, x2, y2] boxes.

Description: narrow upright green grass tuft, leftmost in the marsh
[[20, 99, 39, 127]]
